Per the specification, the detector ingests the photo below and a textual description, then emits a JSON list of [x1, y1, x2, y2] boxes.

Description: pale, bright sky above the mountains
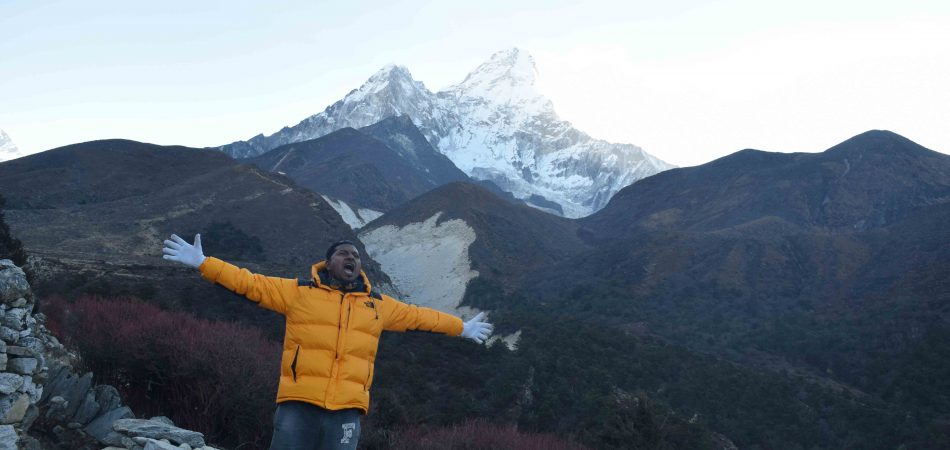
[[0, 0, 950, 166]]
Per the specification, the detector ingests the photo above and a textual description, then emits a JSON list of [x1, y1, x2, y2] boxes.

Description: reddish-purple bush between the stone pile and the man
[[44, 296, 280, 448]]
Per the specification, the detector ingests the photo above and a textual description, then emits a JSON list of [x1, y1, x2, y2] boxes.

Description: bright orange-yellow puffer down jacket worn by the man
[[198, 257, 463, 414]]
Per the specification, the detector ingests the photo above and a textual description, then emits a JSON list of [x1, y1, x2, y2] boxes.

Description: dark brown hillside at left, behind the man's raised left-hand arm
[[0, 140, 398, 335]]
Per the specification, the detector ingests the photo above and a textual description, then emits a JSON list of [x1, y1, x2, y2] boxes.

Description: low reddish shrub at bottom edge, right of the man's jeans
[[393, 420, 585, 450]]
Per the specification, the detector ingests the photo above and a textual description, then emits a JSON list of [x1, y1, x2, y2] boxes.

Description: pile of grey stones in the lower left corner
[[0, 259, 221, 450]]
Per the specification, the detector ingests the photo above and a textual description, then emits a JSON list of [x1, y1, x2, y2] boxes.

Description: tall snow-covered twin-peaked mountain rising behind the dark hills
[[220, 48, 673, 217]]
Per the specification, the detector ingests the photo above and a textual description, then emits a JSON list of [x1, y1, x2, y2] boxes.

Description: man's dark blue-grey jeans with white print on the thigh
[[270, 401, 360, 450]]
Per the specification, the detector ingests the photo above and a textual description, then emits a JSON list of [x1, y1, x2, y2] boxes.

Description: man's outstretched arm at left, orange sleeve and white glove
[[162, 234, 298, 314]]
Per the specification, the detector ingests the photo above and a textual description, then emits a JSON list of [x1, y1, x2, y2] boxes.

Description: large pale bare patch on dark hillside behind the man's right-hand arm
[[359, 212, 478, 317]]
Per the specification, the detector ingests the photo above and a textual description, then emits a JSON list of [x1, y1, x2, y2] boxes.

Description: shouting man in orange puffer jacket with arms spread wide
[[162, 234, 492, 450]]
